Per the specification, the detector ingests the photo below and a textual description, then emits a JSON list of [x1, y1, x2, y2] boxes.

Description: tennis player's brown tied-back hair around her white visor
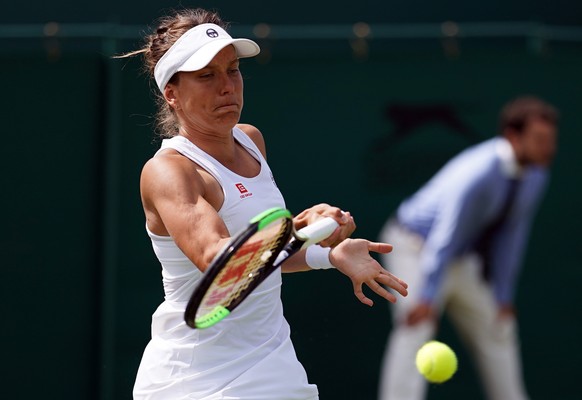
[[117, 8, 228, 137]]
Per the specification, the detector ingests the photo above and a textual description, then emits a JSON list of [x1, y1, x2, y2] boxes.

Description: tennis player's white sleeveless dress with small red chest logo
[[134, 128, 317, 400]]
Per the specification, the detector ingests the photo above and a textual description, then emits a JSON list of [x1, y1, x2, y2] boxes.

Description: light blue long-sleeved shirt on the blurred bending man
[[397, 137, 548, 304]]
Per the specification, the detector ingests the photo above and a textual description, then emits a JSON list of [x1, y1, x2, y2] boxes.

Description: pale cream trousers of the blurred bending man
[[379, 222, 528, 400]]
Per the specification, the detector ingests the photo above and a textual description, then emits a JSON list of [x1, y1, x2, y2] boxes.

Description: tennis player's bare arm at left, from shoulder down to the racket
[[140, 150, 230, 271]]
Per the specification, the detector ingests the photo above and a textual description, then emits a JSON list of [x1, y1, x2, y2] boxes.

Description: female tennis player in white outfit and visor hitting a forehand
[[127, 9, 407, 400]]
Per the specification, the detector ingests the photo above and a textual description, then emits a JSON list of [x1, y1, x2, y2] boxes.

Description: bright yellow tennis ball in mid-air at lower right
[[416, 340, 457, 383]]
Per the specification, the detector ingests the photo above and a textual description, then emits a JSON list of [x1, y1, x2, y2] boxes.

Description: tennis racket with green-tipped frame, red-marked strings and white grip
[[184, 208, 338, 328]]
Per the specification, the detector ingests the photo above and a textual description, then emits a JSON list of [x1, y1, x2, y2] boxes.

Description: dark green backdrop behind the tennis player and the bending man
[[0, 0, 582, 400]]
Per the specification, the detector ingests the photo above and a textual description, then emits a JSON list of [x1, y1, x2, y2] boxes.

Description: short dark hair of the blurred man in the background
[[499, 96, 559, 134]]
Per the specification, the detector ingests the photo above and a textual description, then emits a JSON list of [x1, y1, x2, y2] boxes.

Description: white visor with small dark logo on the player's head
[[154, 24, 261, 92]]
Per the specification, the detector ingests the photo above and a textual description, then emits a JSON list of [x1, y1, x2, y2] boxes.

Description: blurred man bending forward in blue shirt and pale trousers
[[379, 96, 558, 400]]
